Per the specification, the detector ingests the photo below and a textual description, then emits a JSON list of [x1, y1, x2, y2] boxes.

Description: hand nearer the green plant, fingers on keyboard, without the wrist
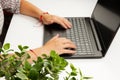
[[42, 34, 76, 55]]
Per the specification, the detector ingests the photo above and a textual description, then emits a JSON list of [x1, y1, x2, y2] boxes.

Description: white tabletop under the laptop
[[4, 0, 120, 80]]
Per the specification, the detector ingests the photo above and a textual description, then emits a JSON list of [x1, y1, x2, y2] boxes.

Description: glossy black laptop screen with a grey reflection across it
[[92, 4, 120, 53]]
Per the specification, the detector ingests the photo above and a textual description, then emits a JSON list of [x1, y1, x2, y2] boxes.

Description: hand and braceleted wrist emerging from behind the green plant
[[28, 34, 76, 63]]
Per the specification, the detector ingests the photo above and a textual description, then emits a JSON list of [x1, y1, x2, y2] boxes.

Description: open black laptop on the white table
[[44, 3, 120, 59]]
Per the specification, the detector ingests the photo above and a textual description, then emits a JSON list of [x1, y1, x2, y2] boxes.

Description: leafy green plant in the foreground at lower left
[[0, 43, 91, 80]]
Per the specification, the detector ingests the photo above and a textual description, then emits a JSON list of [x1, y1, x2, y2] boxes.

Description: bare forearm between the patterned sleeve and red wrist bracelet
[[20, 0, 43, 19]]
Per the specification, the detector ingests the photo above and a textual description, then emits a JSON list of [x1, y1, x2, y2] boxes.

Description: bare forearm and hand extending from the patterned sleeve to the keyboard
[[20, 0, 72, 29]]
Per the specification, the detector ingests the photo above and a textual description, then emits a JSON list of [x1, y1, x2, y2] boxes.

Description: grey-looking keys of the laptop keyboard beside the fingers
[[64, 18, 93, 55]]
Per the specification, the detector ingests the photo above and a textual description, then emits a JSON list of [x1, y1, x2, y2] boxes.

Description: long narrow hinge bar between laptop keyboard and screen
[[90, 20, 102, 51]]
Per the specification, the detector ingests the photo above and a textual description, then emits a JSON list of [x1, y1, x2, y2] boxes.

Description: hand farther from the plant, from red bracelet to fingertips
[[41, 14, 72, 29]]
